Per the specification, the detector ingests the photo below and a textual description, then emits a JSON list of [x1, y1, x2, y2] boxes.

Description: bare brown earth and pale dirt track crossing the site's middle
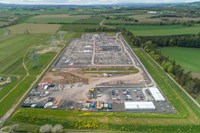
[[42, 68, 144, 103]]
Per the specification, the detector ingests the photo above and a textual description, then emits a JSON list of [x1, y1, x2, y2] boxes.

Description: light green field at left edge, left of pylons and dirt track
[[0, 34, 50, 74]]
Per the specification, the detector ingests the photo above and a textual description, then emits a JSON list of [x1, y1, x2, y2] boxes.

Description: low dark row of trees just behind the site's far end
[[85, 27, 121, 32]]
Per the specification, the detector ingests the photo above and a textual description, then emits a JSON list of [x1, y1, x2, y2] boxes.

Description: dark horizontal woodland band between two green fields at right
[[141, 33, 200, 48]]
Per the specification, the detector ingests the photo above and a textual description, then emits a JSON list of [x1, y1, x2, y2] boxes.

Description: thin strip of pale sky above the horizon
[[0, 0, 197, 5]]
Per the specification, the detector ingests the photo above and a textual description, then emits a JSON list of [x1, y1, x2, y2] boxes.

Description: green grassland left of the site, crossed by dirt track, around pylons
[[0, 32, 75, 117]]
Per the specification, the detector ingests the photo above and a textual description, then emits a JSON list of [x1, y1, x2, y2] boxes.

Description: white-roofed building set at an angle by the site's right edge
[[149, 87, 165, 102]]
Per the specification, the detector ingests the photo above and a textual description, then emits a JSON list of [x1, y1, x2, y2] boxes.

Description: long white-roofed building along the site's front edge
[[125, 102, 156, 110]]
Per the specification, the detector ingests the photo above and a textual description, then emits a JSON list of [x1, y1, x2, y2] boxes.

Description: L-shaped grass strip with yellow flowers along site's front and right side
[[6, 49, 200, 132]]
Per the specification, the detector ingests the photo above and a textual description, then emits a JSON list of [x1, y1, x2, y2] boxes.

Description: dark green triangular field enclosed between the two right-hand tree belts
[[159, 47, 200, 77]]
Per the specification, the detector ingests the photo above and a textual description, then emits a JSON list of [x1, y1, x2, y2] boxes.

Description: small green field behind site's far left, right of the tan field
[[61, 24, 100, 32]]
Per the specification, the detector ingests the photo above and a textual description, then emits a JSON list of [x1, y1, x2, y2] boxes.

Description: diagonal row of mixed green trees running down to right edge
[[142, 41, 200, 96]]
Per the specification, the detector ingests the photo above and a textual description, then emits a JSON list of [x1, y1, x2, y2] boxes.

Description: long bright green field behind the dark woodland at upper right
[[113, 25, 200, 36]]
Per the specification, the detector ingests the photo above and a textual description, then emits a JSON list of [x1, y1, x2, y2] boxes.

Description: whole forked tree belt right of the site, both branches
[[123, 29, 200, 97]]
